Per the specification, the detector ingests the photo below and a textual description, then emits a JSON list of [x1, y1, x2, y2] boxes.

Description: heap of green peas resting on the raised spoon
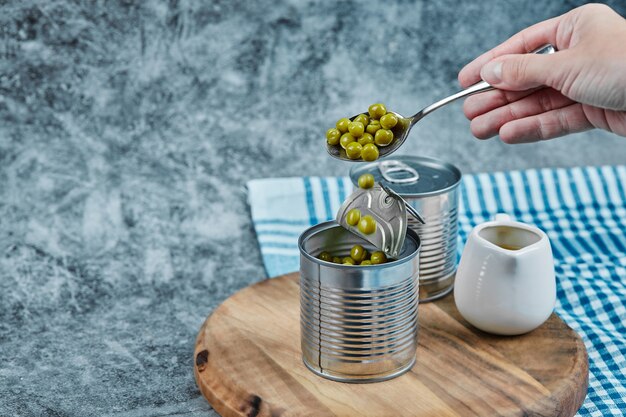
[[326, 103, 398, 161]]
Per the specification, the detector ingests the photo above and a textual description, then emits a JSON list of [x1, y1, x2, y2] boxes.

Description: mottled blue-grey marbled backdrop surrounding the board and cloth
[[0, 0, 626, 416]]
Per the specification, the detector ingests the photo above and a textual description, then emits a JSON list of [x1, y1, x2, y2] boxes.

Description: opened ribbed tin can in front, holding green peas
[[298, 221, 420, 382]]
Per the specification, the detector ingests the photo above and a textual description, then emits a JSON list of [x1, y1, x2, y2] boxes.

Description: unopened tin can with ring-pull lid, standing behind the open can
[[350, 156, 461, 302]]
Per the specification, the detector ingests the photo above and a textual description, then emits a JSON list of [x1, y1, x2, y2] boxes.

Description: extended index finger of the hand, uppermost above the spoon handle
[[459, 15, 563, 88]]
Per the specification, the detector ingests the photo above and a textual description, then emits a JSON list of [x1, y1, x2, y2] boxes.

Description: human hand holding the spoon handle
[[459, 4, 626, 143]]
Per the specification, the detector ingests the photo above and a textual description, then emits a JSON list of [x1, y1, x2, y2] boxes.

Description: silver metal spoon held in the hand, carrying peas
[[326, 44, 556, 162]]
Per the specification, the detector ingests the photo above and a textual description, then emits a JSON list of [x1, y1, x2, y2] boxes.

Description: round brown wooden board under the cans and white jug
[[194, 273, 588, 417]]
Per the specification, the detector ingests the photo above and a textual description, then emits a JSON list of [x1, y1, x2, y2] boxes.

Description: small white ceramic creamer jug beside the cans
[[454, 214, 556, 335]]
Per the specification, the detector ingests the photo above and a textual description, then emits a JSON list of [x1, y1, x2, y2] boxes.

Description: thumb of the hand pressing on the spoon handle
[[480, 54, 559, 91]]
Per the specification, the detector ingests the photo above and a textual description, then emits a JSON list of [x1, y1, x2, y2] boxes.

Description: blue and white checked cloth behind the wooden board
[[248, 166, 626, 417]]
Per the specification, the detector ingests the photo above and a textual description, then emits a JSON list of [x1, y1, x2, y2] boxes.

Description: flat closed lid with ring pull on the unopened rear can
[[350, 156, 461, 197]]
